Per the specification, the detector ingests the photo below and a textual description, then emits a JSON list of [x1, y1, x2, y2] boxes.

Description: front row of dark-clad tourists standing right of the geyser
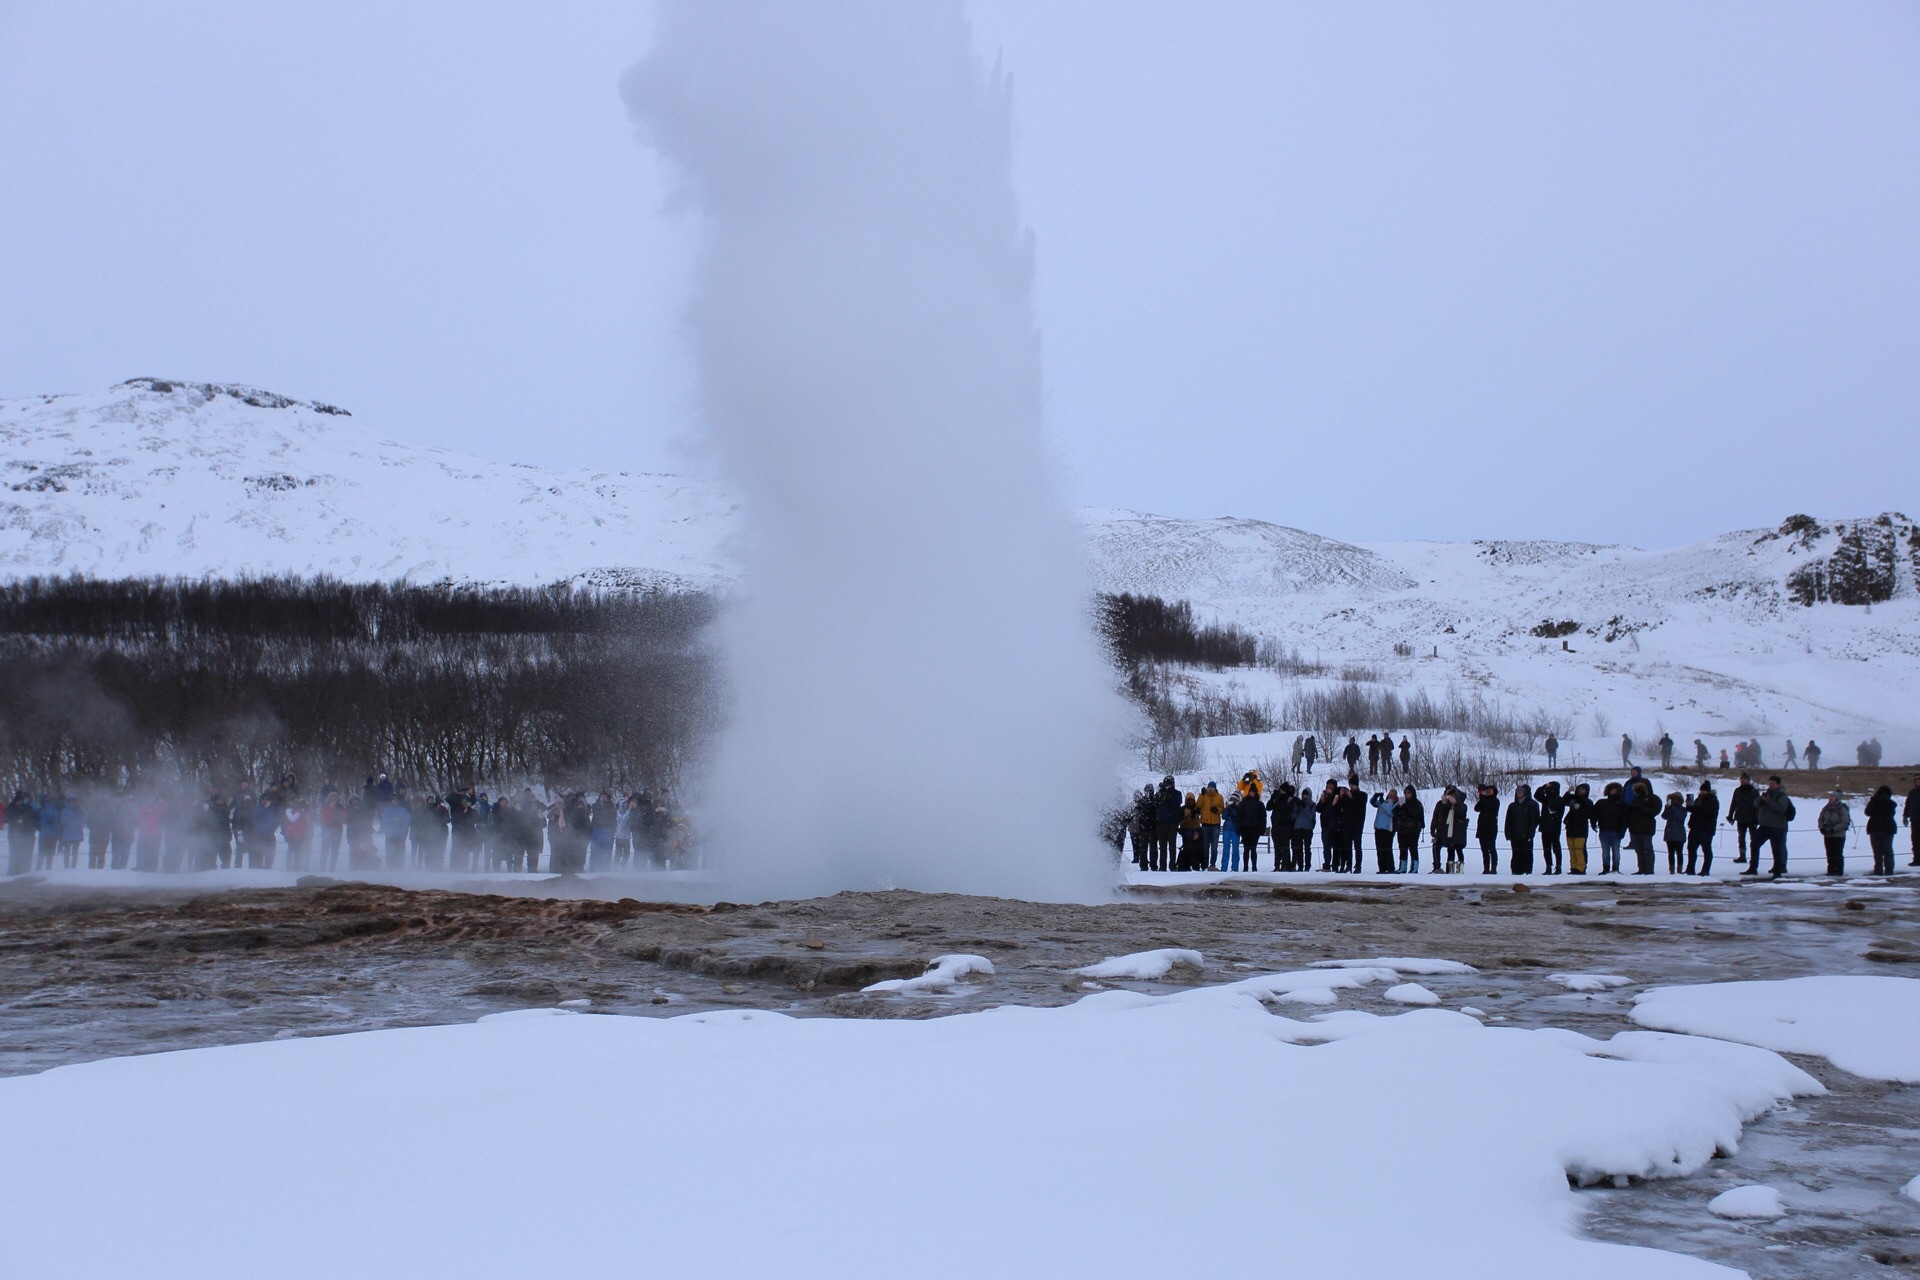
[[1116, 768, 1920, 879]]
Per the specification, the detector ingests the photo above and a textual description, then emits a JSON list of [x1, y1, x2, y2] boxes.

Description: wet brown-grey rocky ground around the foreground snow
[[0, 879, 1920, 1278]]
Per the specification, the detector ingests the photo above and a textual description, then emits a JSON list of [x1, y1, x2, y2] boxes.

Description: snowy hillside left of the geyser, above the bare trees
[[0, 378, 733, 585]]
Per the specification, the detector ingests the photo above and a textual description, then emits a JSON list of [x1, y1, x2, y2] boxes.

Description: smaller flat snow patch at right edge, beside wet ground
[[1634, 975, 1920, 1084]]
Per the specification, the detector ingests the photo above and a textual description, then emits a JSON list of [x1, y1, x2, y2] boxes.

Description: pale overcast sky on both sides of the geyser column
[[0, 0, 1920, 545]]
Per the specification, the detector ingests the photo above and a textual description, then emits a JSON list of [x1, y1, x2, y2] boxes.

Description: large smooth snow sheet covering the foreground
[[0, 975, 1818, 1280]]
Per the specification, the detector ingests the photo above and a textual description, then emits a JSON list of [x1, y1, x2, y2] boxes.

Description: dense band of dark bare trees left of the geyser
[[0, 578, 716, 791]]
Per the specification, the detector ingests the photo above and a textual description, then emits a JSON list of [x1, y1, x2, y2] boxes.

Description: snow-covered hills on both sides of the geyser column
[[0, 378, 1920, 760]]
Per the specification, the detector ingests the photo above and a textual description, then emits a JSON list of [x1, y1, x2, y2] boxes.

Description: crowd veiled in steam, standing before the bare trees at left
[[4, 773, 695, 875]]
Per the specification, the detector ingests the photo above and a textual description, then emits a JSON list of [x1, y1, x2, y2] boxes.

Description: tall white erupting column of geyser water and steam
[[622, 0, 1125, 900]]
